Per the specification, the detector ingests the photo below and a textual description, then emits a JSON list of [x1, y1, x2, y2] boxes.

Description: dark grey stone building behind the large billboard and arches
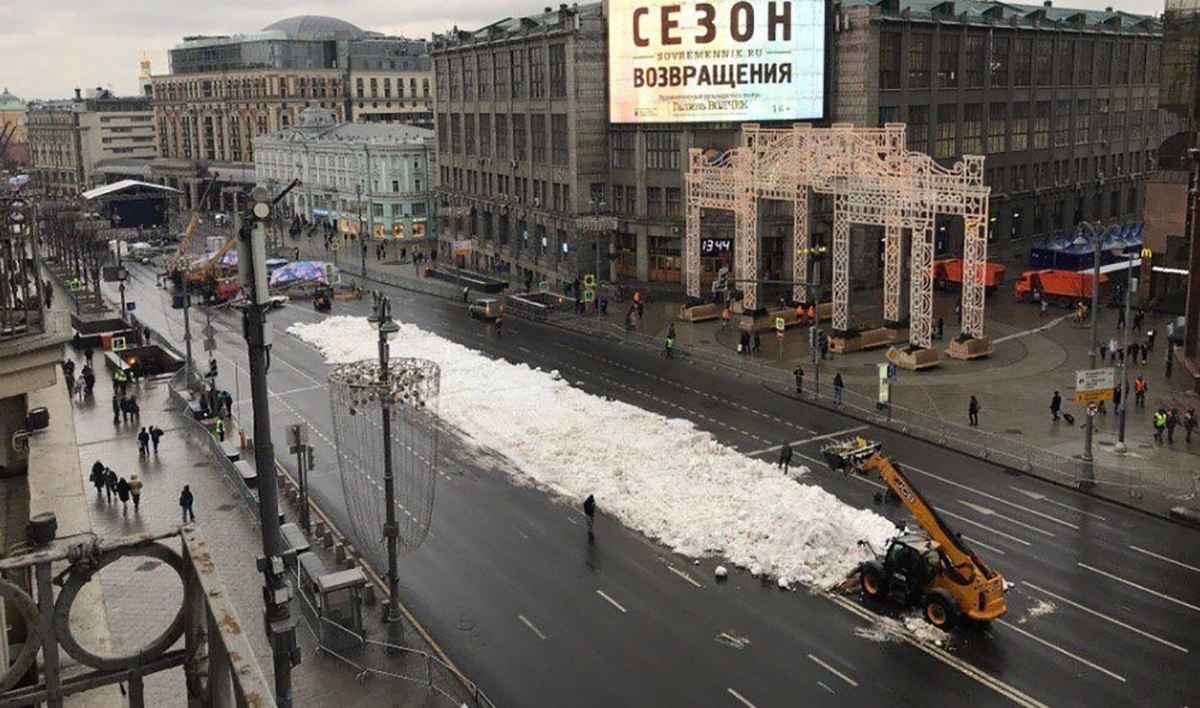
[[433, 0, 1172, 288]]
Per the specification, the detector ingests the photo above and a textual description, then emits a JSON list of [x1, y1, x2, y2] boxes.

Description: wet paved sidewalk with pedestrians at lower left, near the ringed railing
[[60, 338, 460, 708]]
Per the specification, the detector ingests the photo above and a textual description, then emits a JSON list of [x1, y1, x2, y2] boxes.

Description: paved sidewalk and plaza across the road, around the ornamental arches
[[288, 236, 1200, 514]]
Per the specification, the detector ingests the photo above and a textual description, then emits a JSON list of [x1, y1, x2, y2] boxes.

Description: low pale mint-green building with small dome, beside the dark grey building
[[254, 106, 437, 239]]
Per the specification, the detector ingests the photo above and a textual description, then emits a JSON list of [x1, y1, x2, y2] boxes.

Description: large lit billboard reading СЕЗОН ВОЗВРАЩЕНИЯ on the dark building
[[608, 0, 827, 124]]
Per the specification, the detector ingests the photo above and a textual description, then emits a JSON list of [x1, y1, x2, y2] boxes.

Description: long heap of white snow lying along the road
[[289, 317, 895, 588]]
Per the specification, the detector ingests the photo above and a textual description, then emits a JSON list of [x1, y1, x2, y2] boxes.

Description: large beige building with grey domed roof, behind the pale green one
[[150, 16, 432, 205]]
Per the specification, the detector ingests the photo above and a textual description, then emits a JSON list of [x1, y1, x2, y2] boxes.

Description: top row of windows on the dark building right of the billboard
[[880, 31, 1159, 89]]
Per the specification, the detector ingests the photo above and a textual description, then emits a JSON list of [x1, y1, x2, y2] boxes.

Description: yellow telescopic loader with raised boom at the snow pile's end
[[821, 437, 1008, 629]]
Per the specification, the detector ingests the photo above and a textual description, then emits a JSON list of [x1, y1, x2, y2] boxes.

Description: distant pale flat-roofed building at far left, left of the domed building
[[28, 89, 157, 194]]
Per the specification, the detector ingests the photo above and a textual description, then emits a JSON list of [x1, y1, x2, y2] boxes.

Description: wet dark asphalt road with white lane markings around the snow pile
[[108, 268, 1200, 708]]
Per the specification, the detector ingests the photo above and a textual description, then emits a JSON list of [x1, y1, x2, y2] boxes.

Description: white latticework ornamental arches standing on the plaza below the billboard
[[684, 124, 990, 349]]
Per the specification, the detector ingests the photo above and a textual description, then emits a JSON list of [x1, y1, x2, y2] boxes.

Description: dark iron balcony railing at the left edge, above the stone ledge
[[0, 197, 46, 341]]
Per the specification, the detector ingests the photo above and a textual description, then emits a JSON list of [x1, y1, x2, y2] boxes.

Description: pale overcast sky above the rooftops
[[0, 0, 1163, 100]]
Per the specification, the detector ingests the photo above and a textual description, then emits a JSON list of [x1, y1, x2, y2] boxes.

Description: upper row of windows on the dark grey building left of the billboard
[[434, 43, 568, 101]]
